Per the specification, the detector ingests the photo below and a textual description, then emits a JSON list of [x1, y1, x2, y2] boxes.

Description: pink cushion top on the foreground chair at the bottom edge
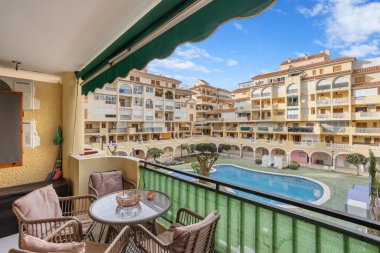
[[21, 235, 85, 253]]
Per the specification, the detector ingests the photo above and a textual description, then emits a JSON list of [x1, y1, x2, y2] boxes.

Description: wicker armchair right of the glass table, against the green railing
[[134, 208, 220, 253]]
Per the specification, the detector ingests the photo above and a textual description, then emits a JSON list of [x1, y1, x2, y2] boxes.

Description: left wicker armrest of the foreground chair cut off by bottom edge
[[44, 219, 82, 243]]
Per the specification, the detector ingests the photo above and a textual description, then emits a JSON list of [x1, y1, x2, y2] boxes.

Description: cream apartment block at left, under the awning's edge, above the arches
[[84, 70, 196, 148]]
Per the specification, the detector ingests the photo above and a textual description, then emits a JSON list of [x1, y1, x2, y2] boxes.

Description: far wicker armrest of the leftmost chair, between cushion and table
[[59, 194, 97, 216]]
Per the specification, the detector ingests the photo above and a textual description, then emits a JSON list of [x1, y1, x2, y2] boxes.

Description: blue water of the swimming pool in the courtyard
[[174, 165, 323, 204]]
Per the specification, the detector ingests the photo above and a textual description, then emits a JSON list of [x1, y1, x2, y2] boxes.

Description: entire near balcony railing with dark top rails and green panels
[[140, 161, 380, 253]]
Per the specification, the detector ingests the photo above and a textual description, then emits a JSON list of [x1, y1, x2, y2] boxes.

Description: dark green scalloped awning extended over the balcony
[[76, 0, 276, 95]]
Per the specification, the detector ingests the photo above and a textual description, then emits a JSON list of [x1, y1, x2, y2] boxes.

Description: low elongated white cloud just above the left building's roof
[[148, 58, 210, 73]]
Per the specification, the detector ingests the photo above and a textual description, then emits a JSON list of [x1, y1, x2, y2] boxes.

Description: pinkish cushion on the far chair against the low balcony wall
[[91, 170, 123, 197]]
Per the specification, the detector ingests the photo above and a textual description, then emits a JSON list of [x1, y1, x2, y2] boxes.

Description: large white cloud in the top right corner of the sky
[[298, 0, 380, 57]]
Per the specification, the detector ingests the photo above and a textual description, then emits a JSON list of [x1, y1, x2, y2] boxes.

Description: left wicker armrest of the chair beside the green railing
[[134, 224, 170, 252]]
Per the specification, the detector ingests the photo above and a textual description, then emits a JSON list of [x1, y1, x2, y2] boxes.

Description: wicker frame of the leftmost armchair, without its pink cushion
[[12, 195, 96, 246]]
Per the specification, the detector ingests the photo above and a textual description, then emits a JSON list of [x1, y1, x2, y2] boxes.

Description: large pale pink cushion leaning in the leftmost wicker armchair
[[13, 184, 62, 220]]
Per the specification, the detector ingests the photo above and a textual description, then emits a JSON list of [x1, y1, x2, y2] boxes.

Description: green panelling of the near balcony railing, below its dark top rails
[[140, 169, 380, 253]]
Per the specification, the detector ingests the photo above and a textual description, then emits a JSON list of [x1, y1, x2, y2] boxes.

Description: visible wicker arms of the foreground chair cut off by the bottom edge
[[9, 221, 130, 253]]
